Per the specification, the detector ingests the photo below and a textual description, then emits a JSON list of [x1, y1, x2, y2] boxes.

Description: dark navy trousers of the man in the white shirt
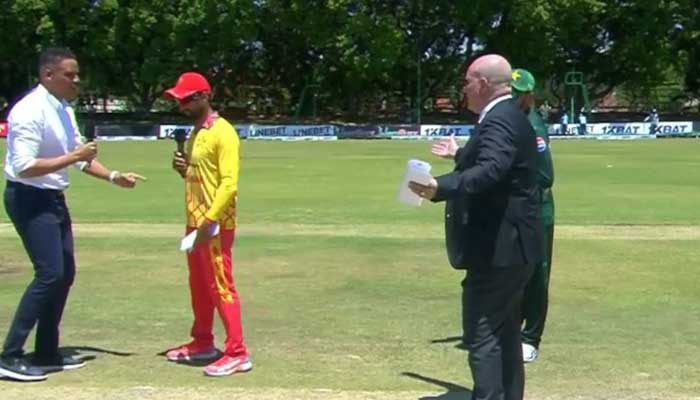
[[2, 181, 75, 357]]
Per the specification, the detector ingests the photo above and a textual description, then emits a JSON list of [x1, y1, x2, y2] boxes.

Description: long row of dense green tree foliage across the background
[[0, 0, 700, 115]]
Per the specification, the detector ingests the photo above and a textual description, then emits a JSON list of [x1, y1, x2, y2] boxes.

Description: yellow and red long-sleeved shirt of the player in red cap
[[185, 114, 240, 229]]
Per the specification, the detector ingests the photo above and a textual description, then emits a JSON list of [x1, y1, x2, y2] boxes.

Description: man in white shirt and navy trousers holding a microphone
[[0, 49, 144, 381]]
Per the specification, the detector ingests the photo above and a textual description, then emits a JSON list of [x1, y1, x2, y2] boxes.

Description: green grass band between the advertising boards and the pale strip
[[0, 139, 700, 227]]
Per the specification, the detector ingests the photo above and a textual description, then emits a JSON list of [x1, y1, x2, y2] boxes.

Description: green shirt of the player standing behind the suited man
[[528, 110, 554, 225]]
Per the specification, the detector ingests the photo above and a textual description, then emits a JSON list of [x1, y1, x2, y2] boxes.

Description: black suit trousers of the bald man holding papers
[[462, 266, 533, 400]]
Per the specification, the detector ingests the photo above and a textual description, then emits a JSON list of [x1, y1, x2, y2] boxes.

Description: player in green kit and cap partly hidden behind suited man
[[511, 69, 554, 363]]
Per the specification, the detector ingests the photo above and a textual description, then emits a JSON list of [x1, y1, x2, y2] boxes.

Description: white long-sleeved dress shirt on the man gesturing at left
[[4, 85, 86, 190]]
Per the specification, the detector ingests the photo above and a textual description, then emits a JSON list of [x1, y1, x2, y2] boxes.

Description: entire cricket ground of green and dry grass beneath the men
[[0, 140, 700, 400]]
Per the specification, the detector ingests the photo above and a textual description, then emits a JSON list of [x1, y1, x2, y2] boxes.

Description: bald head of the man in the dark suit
[[464, 54, 512, 114]]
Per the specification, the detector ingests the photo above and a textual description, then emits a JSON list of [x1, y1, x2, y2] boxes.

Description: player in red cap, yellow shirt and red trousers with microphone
[[166, 72, 253, 376]]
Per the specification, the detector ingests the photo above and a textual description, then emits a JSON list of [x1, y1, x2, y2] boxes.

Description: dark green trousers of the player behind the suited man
[[522, 221, 554, 348]]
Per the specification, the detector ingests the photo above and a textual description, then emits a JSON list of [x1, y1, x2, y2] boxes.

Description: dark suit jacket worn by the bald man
[[433, 100, 544, 269]]
